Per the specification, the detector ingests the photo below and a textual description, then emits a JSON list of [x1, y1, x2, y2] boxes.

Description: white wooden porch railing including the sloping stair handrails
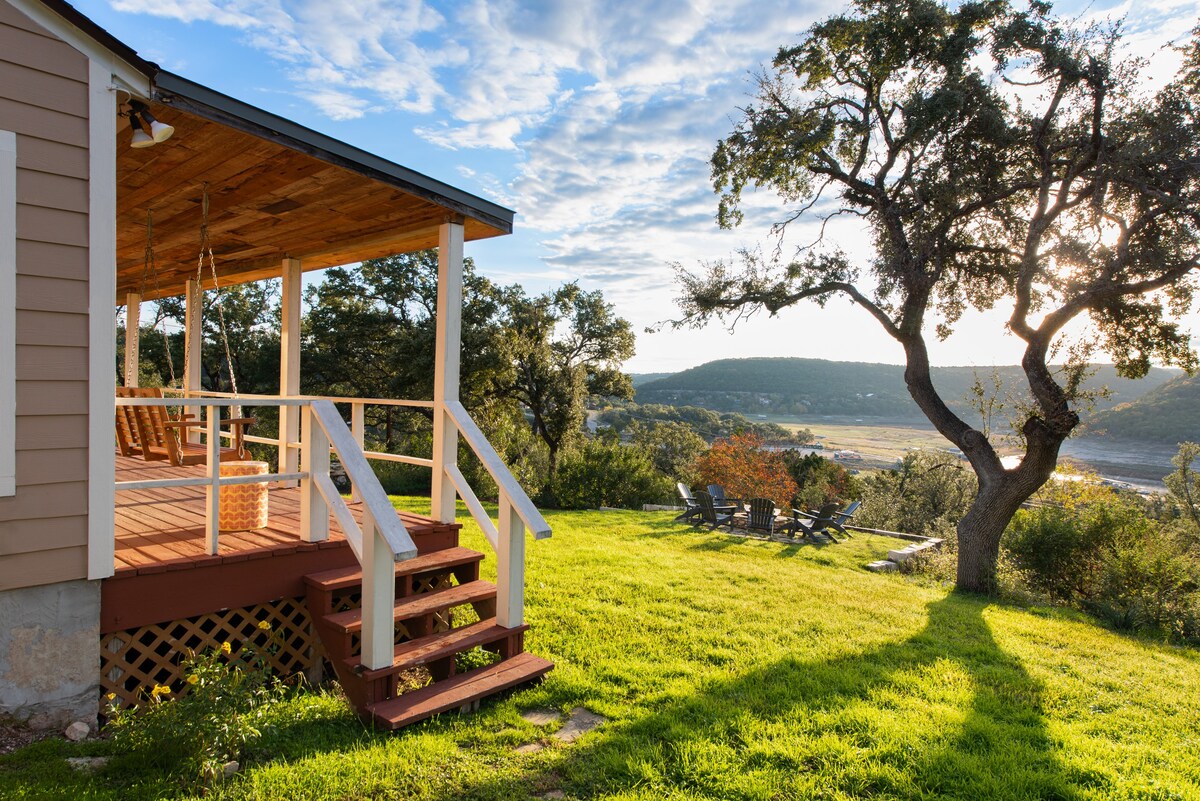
[[118, 392, 551, 668]]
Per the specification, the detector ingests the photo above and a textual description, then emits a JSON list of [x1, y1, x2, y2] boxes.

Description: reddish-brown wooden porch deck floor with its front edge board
[[101, 456, 460, 632]]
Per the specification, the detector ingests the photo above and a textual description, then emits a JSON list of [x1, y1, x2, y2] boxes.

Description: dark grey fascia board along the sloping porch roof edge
[[151, 71, 515, 234]]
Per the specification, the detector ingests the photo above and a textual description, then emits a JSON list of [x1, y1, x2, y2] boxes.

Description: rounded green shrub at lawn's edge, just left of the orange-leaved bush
[[554, 441, 672, 508]]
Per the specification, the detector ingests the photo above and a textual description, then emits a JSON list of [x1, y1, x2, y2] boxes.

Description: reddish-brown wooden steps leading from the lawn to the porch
[[304, 543, 554, 729]]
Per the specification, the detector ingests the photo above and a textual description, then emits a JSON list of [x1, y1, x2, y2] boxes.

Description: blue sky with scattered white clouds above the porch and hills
[[76, 0, 1200, 372]]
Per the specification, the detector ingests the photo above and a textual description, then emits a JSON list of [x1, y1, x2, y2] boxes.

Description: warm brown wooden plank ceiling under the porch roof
[[116, 106, 505, 302]]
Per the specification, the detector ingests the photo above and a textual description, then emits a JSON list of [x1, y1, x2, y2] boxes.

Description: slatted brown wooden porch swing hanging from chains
[[116, 387, 258, 468]]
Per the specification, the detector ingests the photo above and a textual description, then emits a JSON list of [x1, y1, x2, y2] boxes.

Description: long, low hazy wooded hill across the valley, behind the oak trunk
[[636, 357, 1182, 421]]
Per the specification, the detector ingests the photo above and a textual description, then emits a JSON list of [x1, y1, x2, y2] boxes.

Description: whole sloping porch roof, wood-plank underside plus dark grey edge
[[116, 72, 514, 302]]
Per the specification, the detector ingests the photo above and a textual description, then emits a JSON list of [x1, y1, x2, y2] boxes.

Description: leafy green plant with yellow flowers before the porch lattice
[[106, 621, 283, 782]]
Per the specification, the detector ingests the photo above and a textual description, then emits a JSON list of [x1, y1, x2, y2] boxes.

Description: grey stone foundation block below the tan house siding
[[0, 580, 100, 729]]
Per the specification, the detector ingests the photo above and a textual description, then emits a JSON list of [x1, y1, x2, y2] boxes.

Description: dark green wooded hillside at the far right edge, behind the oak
[[1085, 375, 1200, 445]]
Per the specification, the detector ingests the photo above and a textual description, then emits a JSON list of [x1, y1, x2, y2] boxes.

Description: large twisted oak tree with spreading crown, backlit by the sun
[[677, 0, 1200, 591]]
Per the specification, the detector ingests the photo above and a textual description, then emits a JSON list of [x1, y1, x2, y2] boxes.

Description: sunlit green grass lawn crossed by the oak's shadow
[[0, 501, 1200, 801]]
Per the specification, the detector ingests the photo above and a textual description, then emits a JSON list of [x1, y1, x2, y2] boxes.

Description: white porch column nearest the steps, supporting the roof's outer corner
[[430, 221, 463, 523]]
